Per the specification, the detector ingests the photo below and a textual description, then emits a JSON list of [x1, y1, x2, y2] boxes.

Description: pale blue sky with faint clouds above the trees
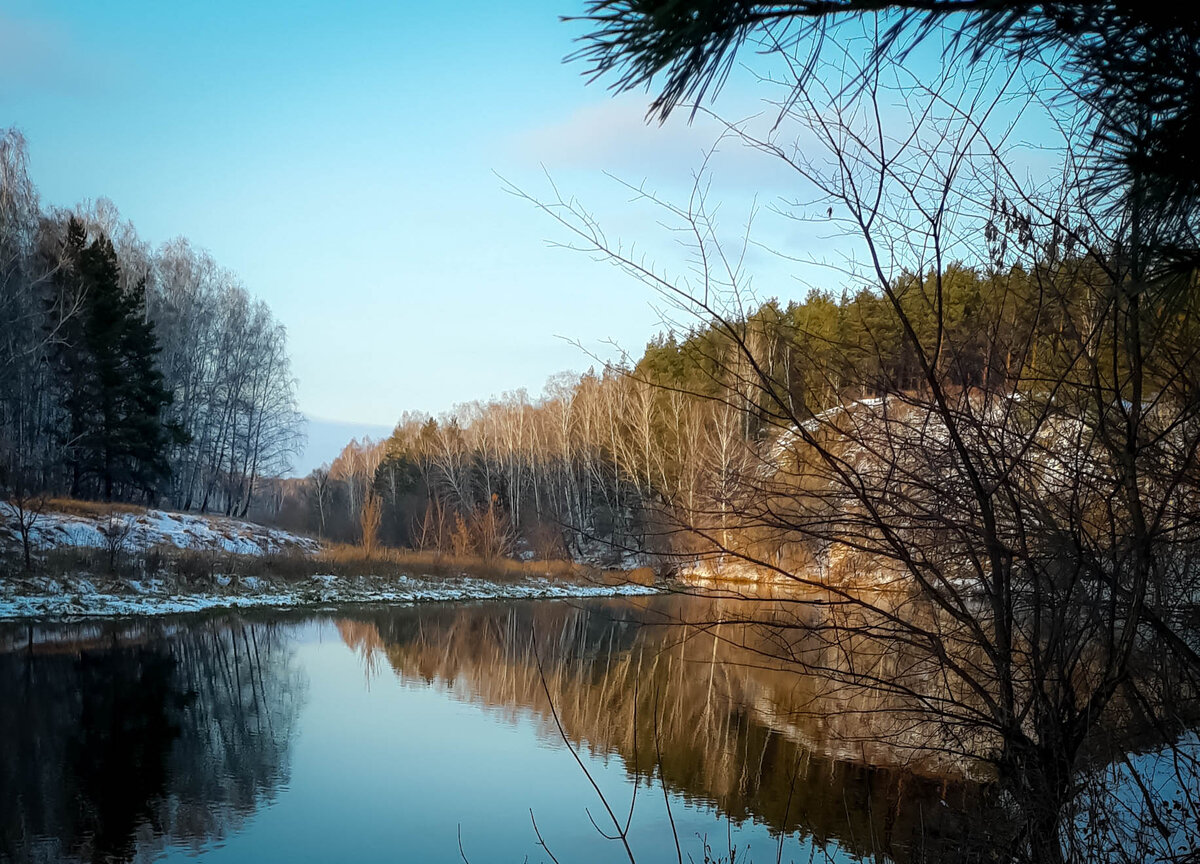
[[0, 0, 1022, 472]]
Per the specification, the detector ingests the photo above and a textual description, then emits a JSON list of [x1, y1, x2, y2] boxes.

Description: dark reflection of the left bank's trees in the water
[[0, 618, 305, 862]]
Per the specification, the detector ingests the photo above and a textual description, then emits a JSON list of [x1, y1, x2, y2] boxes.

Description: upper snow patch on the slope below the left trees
[[0, 502, 319, 556]]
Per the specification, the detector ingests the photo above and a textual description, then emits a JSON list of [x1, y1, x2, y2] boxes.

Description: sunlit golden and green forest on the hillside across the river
[[277, 259, 1147, 560]]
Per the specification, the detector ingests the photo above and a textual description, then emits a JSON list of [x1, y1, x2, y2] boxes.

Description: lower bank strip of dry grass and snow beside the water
[[0, 547, 656, 620]]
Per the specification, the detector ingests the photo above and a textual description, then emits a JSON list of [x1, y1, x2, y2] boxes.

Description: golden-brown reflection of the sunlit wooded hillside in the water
[[338, 598, 997, 860]]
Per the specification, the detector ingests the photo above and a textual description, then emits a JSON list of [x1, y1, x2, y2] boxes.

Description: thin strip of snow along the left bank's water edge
[[0, 575, 659, 620]]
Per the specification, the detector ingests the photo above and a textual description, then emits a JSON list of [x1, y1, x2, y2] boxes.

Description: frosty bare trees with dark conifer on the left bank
[[0, 130, 302, 515]]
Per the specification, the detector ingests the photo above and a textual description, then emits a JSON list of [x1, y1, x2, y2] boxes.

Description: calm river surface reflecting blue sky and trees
[[0, 598, 974, 864]]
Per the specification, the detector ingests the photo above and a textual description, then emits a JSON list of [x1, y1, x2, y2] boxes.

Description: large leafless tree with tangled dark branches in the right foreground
[[523, 28, 1200, 862]]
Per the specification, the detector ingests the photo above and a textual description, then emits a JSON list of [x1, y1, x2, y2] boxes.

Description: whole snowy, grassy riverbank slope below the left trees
[[0, 502, 659, 619]]
